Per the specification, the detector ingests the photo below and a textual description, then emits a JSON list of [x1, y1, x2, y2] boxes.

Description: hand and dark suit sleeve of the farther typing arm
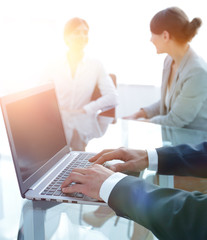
[[90, 142, 207, 177]]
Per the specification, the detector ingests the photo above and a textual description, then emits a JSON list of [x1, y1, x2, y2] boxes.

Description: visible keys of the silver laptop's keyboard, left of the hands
[[41, 152, 94, 198]]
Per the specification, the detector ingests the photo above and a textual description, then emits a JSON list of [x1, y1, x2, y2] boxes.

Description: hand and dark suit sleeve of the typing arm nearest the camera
[[62, 164, 207, 240]]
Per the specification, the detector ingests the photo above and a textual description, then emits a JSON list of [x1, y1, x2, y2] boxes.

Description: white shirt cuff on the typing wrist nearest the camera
[[99, 172, 127, 203]]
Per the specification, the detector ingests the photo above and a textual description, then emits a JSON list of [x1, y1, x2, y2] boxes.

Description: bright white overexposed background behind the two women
[[0, 0, 207, 94]]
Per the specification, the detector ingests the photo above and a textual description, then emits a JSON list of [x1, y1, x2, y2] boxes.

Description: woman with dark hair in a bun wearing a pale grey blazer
[[124, 7, 207, 130]]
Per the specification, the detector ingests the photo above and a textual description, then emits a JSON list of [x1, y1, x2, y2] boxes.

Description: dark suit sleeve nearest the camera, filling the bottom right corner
[[108, 176, 207, 240]]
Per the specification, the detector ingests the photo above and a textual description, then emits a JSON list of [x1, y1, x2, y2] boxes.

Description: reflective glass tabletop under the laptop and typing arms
[[0, 115, 207, 240]]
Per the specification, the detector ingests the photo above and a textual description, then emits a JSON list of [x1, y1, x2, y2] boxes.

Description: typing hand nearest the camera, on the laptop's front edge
[[61, 164, 114, 200]]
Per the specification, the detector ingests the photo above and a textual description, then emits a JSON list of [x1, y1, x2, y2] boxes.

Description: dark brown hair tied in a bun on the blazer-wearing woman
[[150, 7, 202, 43]]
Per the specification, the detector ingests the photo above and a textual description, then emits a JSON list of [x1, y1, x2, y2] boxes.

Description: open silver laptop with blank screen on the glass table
[[1, 83, 105, 205]]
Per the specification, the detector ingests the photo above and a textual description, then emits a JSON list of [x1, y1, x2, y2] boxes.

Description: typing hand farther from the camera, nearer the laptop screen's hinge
[[89, 148, 149, 172]]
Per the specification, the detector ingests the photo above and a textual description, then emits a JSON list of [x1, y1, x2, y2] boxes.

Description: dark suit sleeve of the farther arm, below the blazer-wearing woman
[[156, 142, 207, 177]]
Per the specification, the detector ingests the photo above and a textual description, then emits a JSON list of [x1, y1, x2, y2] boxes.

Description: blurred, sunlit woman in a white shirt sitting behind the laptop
[[47, 17, 118, 148]]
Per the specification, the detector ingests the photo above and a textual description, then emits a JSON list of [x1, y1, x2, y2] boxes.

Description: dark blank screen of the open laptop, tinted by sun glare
[[1, 84, 67, 182]]
